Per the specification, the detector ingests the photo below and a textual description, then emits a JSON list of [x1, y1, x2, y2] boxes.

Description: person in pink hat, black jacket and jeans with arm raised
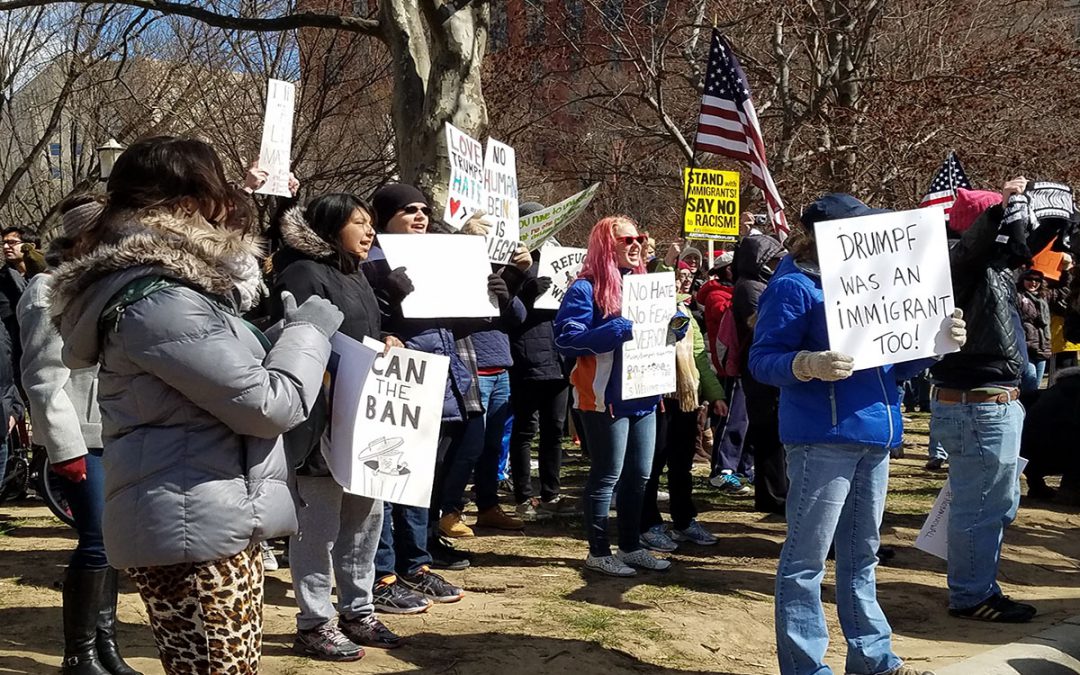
[[931, 177, 1071, 623]]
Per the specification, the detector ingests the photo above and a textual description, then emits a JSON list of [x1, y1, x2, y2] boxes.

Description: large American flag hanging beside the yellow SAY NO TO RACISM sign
[[694, 28, 788, 241]]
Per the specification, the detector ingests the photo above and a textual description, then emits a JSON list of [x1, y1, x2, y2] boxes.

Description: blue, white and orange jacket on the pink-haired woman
[[555, 279, 686, 417]]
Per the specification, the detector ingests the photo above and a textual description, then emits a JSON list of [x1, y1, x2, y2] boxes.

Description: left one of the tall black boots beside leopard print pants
[[60, 567, 110, 675]]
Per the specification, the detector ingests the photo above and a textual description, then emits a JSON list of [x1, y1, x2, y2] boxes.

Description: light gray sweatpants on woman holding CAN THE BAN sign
[[288, 476, 382, 631]]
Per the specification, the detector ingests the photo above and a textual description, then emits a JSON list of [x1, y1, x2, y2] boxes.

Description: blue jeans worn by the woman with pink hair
[[581, 410, 657, 556]]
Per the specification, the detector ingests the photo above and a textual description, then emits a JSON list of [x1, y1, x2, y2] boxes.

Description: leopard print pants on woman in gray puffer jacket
[[127, 544, 262, 675]]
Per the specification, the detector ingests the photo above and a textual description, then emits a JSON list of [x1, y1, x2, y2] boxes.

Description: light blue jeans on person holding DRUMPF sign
[[775, 445, 901, 675]]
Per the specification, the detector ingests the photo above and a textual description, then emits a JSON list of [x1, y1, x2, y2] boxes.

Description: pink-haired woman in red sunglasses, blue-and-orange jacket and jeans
[[555, 216, 687, 577]]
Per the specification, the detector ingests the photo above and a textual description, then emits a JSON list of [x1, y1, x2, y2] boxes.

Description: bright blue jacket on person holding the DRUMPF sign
[[750, 256, 934, 448]]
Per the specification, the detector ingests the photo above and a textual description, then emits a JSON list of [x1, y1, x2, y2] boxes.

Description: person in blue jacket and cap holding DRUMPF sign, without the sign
[[750, 194, 967, 675]]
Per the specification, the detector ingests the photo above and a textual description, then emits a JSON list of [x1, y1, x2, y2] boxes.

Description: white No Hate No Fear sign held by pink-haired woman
[[622, 272, 675, 400]]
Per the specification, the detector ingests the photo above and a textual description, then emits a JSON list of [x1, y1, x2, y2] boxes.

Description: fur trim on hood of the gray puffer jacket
[[51, 212, 264, 367]]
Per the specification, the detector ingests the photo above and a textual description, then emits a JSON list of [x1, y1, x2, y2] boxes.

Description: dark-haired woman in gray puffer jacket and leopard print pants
[[52, 137, 341, 674]]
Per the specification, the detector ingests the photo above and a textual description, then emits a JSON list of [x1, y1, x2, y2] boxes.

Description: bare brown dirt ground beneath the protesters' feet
[[0, 415, 1080, 675]]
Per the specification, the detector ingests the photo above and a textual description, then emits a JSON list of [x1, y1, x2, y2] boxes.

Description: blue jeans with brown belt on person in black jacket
[[932, 401, 1024, 609]]
